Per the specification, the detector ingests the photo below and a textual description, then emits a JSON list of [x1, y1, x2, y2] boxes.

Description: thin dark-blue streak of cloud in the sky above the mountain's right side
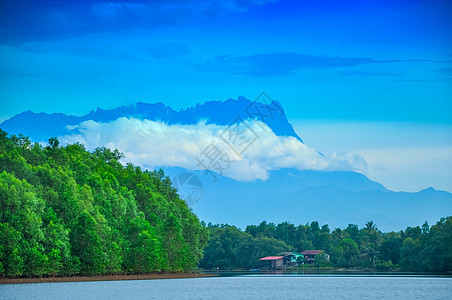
[[196, 53, 425, 77]]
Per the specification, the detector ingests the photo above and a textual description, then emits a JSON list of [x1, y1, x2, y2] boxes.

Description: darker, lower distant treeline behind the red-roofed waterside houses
[[200, 217, 452, 272]]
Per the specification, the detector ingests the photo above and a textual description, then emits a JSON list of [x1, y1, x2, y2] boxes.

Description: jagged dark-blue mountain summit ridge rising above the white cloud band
[[0, 97, 302, 142]]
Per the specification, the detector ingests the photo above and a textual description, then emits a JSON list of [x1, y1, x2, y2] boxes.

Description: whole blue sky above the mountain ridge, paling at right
[[0, 0, 452, 192]]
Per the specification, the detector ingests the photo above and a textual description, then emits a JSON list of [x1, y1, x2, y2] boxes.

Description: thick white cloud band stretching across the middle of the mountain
[[60, 118, 367, 181]]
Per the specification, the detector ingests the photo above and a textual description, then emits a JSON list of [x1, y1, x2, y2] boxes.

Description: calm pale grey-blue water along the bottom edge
[[0, 275, 452, 299]]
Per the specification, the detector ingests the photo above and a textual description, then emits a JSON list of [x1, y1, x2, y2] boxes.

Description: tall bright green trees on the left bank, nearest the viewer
[[0, 130, 208, 277]]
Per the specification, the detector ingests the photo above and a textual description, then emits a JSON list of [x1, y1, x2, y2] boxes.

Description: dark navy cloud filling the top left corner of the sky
[[0, 0, 276, 45]]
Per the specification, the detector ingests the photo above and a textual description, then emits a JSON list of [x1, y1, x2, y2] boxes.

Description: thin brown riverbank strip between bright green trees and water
[[0, 273, 216, 284]]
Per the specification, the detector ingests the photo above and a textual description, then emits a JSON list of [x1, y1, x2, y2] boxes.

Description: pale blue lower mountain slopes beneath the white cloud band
[[165, 168, 452, 231]]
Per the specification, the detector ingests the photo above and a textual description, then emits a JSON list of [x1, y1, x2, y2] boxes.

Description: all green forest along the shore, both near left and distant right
[[0, 130, 452, 277]]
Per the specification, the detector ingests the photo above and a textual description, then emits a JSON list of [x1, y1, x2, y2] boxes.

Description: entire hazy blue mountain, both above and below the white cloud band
[[0, 97, 452, 231]]
